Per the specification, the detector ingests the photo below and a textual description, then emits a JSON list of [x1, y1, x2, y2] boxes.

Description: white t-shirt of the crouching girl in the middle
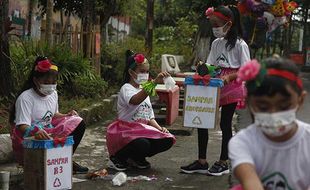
[[117, 83, 154, 123]]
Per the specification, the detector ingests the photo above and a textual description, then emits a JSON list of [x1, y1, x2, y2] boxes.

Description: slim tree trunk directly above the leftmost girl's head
[[45, 0, 53, 44]]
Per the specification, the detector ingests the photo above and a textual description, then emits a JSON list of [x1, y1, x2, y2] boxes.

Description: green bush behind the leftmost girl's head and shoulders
[[10, 40, 106, 96]]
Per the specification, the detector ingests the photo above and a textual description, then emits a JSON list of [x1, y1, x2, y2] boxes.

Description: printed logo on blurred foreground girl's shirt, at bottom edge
[[262, 172, 292, 190]]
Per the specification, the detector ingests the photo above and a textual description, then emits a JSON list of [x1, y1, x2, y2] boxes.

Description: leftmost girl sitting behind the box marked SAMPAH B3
[[10, 57, 88, 173]]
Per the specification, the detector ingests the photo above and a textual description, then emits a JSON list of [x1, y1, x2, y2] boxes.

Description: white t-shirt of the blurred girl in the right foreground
[[229, 121, 310, 190]]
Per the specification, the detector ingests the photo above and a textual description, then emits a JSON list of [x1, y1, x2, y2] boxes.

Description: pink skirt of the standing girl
[[218, 68, 246, 109]]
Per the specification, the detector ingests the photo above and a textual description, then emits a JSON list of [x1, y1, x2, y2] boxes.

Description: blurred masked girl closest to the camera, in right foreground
[[229, 58, 310, 190]]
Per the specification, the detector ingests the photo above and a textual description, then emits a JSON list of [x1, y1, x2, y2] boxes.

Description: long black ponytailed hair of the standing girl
[[215, 5, 242, 50]]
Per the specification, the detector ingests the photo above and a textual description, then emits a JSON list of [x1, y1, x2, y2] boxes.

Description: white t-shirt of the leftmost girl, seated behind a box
[[15, 88, 58, 126]]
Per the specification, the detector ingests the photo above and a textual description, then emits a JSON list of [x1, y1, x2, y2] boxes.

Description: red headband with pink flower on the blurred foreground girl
[[237, 59, 303, 89]]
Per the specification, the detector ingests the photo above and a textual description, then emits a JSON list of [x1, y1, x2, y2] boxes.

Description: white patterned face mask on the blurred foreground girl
[[253, 108, 297, 137]]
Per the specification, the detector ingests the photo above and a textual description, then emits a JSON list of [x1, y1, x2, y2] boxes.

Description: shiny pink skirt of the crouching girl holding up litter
[[106, 120, 175, 156]]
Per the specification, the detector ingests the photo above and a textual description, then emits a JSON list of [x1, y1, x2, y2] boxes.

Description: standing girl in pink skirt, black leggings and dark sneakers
[[181, 6, 250, 176]]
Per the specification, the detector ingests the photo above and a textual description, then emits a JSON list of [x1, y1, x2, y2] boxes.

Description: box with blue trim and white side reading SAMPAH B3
[[23, 136, 74, 190]]
